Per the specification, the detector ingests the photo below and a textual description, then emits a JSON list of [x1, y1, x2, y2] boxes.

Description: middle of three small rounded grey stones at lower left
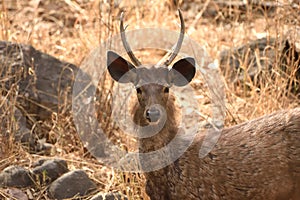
[[32, 159, 69, 184]]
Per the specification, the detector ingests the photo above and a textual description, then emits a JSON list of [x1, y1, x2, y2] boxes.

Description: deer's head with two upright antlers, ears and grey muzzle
[[107, 10, 196, 124]]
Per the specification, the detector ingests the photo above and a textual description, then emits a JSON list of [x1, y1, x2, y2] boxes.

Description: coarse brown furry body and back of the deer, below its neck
[[146, 108, 300, 199]]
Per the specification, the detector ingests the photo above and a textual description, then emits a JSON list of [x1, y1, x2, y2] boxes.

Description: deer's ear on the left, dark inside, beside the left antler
[[107, 51, 136, 83]]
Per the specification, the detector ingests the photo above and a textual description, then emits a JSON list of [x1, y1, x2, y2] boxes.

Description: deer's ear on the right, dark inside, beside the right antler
[[169, 57, 196, 86]]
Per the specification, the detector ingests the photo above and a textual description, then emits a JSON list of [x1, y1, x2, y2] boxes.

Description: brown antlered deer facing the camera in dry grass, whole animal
[[107, 11, 300, 200]]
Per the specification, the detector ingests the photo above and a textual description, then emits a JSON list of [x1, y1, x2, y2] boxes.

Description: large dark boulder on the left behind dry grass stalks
[[0, 41, 95, 154]]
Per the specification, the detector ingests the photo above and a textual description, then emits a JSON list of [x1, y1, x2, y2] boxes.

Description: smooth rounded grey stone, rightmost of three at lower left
[[49, 170, 96, 199]]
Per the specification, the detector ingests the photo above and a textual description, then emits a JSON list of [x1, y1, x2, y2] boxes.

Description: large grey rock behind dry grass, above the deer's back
[[220, 38, 300, 94]]
